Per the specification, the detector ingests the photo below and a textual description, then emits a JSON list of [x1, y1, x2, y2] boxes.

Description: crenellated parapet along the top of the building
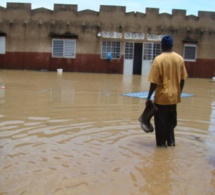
[[0, 2, 215, 22]]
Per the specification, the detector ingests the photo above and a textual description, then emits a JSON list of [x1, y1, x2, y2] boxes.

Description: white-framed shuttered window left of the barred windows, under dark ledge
[[52, 39, 76, 58]]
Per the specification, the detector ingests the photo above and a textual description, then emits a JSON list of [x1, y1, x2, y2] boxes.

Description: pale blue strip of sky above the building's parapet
[[0, 0, 215, 16]]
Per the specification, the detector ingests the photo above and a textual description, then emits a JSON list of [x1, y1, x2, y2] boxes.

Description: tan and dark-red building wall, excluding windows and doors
[[0, 3, 215, 77]]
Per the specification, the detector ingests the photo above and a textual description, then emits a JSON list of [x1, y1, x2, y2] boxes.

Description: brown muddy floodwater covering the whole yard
[[0, 70, 215, 195]]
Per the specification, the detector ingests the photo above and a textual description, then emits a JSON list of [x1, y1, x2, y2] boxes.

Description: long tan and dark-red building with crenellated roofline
[[0, 3, 215, 78]]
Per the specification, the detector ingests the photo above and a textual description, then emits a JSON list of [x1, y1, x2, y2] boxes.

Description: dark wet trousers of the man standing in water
[[154, 104, 177, 146]]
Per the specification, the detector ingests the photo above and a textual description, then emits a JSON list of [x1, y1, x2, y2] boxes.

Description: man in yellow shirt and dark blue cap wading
[[146, 35, 188, 147]]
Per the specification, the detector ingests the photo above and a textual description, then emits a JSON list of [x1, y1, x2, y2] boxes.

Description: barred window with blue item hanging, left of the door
[[101, 41, 121, 59]]
